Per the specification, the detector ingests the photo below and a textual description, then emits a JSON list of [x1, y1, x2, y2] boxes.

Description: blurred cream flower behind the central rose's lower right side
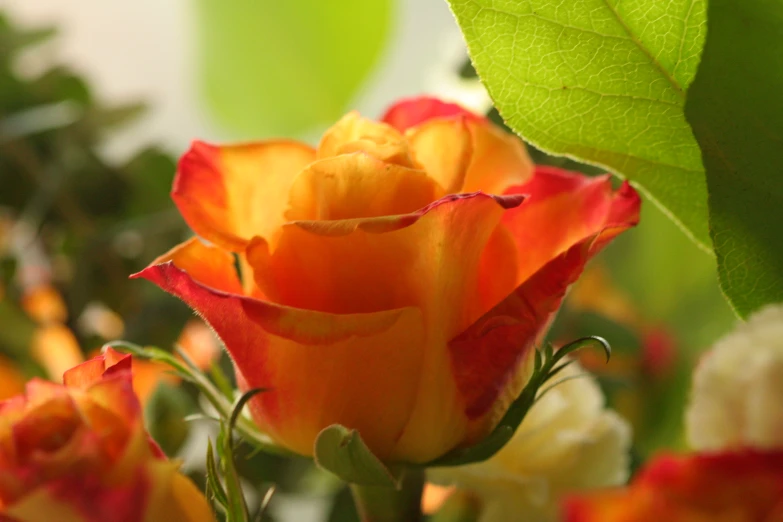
[[429, 363, 631, 522]]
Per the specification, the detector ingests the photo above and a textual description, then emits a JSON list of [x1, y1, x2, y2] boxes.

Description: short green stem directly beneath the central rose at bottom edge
[[351, 468, 424, 522]]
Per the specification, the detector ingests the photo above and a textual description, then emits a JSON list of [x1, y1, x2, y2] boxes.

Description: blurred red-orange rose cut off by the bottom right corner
[[564, 450, 783, 522]]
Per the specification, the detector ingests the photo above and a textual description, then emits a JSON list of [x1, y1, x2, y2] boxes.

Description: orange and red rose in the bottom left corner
[[0, 349, 214, 522]]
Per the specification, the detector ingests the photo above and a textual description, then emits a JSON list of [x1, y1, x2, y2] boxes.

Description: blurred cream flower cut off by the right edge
[[685, 305, 783, 451]]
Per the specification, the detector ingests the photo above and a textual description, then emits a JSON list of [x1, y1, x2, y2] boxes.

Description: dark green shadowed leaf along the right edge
[[685, 0, 783, 316]]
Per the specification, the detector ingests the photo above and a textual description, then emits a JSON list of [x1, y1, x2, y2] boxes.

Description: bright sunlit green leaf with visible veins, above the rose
[[449, 0, 710, 248]]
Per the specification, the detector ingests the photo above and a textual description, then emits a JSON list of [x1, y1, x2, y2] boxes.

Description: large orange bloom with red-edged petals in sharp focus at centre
[[137, 98, 640, 462]]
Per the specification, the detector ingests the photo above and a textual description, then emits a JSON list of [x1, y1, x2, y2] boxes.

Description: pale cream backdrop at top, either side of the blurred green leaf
[[0, 0, 472, 157]]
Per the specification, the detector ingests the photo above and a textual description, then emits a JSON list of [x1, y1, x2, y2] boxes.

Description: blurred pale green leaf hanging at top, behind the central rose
[[196, 0, 393, 137]]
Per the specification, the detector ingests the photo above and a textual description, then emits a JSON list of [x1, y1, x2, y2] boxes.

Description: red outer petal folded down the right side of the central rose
[[438, 168, 640, 438]]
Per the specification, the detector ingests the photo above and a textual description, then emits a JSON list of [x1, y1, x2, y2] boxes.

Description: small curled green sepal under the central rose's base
[[314, 424, 398, 487]]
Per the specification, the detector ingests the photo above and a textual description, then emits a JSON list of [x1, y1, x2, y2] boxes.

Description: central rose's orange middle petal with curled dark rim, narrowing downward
[[248, 193, 522, 461]]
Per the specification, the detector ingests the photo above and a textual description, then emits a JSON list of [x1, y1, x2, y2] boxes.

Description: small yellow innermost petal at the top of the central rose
[[316, 111, 413, 168]]
